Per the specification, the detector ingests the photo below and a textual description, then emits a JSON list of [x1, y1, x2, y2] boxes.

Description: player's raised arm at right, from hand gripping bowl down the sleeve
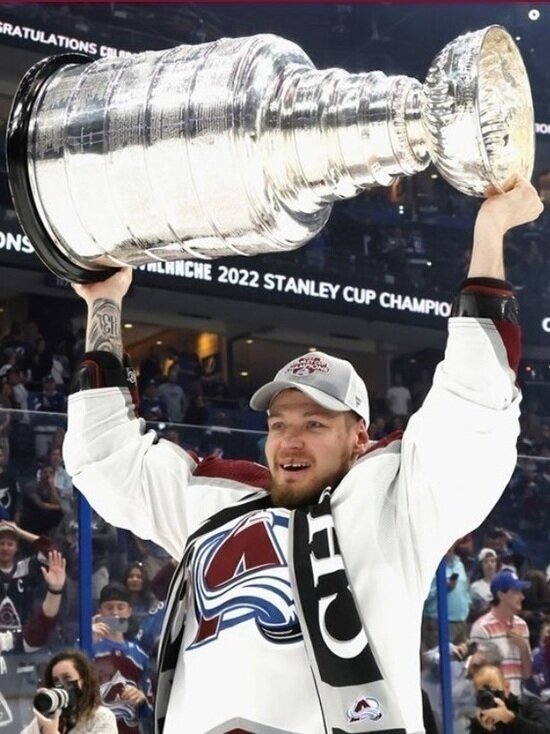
[[394, 177, 543, 585]]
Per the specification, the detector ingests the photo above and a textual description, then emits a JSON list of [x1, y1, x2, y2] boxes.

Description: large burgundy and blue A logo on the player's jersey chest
[[189, 510, 302, 649]]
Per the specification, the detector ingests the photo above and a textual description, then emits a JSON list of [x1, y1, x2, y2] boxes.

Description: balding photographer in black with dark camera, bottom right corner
[[470, 665, 550, 734]]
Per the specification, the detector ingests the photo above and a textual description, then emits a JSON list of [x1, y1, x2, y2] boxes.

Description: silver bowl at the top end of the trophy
[[422, 26, 535, 196]]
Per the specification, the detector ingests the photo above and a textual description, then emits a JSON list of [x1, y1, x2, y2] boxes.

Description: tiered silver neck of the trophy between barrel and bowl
[[263, 68, 429, 213]]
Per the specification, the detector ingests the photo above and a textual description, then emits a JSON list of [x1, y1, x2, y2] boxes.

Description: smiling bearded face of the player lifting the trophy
[[265, 390, 368, 508]]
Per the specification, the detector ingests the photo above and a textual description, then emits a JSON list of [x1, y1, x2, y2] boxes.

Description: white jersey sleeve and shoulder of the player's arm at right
[[333, 317, 521, 599]]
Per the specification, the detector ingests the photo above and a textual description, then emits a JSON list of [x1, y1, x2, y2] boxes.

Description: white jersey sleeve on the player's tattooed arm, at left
[[63, 387, 258, 559]]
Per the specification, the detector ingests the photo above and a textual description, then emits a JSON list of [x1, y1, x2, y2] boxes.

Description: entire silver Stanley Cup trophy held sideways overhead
[[7, 26, 534, 282]]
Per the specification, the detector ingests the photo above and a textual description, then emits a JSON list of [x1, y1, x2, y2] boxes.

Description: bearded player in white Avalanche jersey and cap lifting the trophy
[[64, 179, 542, 734]]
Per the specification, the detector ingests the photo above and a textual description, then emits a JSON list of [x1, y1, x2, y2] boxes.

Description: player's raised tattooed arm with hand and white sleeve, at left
[[63, 268, 260, 558]]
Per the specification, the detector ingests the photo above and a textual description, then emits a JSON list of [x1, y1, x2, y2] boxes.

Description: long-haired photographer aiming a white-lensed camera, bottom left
[[21, 650, 117, 734]]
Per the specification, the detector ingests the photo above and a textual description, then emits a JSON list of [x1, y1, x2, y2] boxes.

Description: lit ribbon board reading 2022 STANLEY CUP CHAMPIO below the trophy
[[0, 224, 550, 344]]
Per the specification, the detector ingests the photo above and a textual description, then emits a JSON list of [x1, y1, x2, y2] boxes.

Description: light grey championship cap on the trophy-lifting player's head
[[250, 352, 369, 426]]
